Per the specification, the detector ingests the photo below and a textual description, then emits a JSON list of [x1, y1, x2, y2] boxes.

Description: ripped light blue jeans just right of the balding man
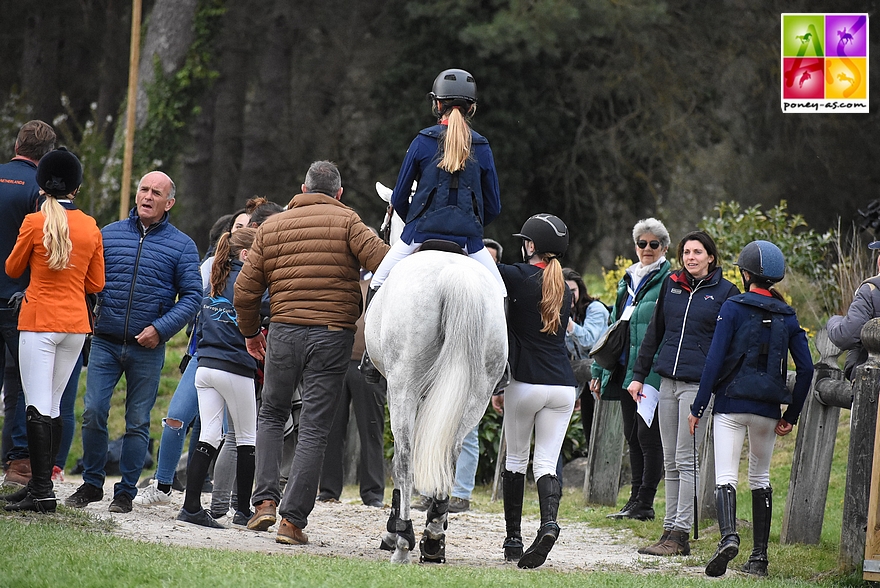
[[156, 357, 199, 484]]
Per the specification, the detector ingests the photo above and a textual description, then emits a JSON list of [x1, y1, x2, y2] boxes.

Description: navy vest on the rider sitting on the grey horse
[[406, 125, 488, 237]]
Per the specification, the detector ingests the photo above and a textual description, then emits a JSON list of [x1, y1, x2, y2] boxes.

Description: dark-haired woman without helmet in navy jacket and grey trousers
[[627, 231, 739, 556]]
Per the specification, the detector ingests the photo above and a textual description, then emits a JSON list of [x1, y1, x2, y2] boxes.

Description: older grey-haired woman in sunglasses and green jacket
[[590, 218, 669, 521]]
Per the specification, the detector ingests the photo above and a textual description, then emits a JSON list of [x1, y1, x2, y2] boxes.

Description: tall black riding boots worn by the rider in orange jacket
[[6, 406, 60, 513]]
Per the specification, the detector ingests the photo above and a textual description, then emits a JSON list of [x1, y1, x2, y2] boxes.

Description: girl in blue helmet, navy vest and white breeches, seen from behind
[[688, 241, 813, 576]]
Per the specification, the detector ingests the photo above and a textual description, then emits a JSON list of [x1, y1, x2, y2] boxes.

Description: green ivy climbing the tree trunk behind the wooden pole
[[132, 0, 226, 180]]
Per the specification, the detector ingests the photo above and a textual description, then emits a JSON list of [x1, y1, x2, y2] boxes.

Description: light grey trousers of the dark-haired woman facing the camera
[[657, 378, 706, 532]]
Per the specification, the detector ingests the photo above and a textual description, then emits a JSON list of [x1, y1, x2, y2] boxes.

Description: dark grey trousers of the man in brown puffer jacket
[[252, 323, 354, 529]]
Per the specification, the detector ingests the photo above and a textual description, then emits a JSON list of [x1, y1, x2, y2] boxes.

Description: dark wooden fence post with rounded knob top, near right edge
[[839, 319, 880, 570]]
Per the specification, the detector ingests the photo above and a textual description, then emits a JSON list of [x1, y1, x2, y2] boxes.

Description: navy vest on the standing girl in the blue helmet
[[721, 294, 794, 404]]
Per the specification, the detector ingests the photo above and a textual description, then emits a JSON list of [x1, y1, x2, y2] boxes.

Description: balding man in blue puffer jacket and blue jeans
[[66, 171, 202, 512]]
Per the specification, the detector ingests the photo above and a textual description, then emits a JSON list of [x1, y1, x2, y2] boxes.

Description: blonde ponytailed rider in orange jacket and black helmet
[[6, 148, 104, 512]]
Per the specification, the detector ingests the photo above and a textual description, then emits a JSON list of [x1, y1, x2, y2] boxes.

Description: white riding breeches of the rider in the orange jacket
[[18, 331, 86, 419]]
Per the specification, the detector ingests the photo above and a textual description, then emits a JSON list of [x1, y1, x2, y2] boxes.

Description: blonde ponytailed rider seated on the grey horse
[[370, 69, 504, 290]]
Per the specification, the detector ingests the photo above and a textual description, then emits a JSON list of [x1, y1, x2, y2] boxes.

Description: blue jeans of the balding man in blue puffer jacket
[[82, 337, 165, 498]]
